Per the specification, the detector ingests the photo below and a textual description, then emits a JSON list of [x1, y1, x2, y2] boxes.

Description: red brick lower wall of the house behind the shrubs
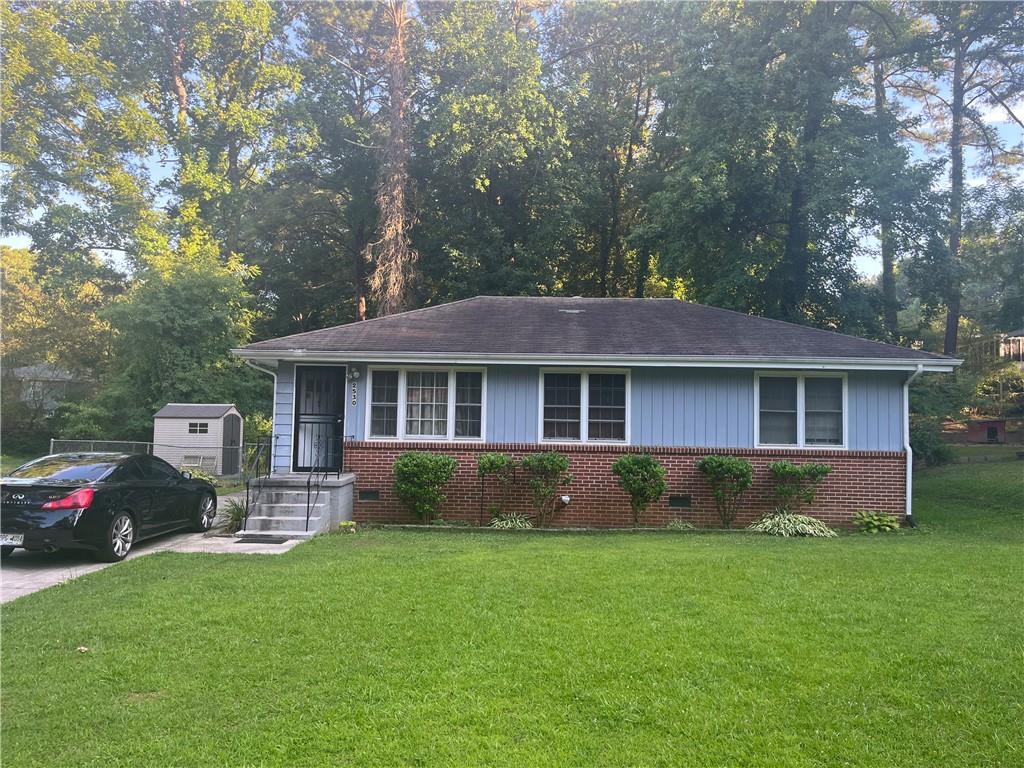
[[345, 440, 906, 527]]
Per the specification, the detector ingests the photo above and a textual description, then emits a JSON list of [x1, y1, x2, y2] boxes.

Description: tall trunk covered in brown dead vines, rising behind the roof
[[367, 0, 417, 314]]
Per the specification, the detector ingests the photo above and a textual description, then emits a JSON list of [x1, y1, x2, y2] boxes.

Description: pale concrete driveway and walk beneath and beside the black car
[[0, 534, 300, 603]]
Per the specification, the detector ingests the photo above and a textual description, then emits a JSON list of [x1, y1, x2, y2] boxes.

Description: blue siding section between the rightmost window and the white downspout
[[847, 371, 907, 451]]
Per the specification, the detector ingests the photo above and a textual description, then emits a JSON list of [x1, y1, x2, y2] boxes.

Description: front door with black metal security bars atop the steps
[[292, 366, 345, 472]]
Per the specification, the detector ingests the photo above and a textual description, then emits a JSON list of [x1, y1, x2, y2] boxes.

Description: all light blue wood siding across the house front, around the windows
[[273, 361, 906, 460]]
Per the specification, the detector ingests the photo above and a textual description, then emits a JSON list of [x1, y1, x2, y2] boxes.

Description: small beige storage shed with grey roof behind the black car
[[153, 402, 242, 475]]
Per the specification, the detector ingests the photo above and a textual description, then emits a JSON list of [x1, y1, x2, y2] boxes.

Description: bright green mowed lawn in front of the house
[[2, 463, 1024, 767]]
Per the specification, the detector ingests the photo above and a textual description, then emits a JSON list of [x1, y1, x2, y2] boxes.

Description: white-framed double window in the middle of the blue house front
[[538, 369, 630, 443]]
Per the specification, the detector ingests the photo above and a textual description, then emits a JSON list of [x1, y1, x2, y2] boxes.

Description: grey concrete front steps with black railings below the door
[[238, 474, 355, 539]]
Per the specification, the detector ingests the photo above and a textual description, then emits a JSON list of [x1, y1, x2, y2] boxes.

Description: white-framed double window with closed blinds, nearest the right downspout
[[754, 371, 848, 449]]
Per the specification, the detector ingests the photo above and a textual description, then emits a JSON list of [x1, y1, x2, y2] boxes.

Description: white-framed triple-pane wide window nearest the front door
[[367, 368, 486, 440]]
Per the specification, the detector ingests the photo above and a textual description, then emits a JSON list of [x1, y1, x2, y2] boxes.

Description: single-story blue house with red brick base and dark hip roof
[[234, 296, 959, 527]]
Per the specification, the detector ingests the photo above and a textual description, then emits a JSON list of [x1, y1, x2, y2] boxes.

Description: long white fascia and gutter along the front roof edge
[[231, 349, 963, 373]]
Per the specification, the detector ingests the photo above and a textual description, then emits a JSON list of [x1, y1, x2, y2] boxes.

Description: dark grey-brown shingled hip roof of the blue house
[[242, 296, 952, 361]]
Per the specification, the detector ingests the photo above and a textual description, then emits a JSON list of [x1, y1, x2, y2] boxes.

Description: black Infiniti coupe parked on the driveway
[[0, 454, 217, 562]]
